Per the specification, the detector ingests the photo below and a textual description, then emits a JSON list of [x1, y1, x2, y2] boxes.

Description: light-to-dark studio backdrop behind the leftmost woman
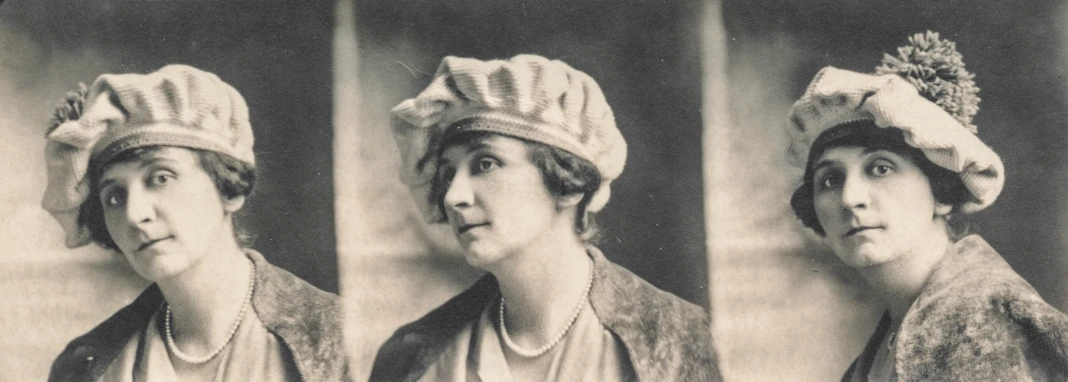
[[0, 0, 339, 381]]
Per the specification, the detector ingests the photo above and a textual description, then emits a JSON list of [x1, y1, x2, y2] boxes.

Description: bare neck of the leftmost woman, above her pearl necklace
[[157, 225, 252, 354]]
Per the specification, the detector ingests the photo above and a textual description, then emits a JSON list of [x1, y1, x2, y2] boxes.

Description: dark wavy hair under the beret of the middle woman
[[427, 131, 601, 244]]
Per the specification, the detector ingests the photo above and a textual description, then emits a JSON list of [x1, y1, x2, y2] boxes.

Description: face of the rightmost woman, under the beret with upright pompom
[[813, 146, 952, 269]]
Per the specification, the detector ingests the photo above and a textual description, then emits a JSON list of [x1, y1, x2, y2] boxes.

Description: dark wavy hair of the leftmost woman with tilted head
[[78, 146, 258, 252]]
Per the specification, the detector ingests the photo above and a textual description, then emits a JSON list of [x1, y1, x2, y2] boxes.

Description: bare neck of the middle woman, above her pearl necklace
[[487, 217, 593, 349]]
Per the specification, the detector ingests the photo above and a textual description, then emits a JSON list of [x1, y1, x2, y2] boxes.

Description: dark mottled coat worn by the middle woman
[[371, 246, 722, 382]]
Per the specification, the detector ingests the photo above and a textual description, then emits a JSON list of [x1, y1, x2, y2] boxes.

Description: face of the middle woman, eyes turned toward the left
[[438, 134, 561, 268]]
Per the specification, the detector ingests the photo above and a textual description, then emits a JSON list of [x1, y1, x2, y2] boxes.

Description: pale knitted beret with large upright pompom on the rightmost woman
[[788, 31, 1005, 213]]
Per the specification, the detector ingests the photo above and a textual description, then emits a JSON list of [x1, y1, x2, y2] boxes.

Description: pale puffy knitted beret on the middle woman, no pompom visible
[[392, 54, 627, 221]]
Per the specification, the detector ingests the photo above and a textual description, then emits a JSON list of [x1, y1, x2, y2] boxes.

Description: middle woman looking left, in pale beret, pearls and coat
[[371, 55, 720, 381]]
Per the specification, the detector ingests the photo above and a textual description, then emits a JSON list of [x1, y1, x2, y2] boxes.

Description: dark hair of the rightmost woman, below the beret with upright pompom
[[790, 121, 971, 236]]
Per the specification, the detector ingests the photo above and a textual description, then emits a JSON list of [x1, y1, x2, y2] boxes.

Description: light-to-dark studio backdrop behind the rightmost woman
[[706, 0, 1068, 381]]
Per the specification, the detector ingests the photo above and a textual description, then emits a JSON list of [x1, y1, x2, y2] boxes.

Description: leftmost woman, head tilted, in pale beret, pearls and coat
[[44, 65, 348, 381]]
